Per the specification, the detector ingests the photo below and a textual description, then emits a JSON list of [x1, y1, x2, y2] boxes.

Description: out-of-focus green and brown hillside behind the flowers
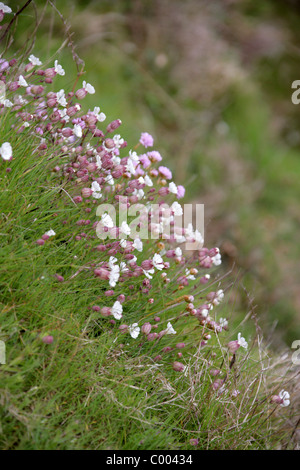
[[6, 0, 300, 345]]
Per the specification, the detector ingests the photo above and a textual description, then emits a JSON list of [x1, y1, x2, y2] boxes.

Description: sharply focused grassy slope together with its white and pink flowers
[[0, 3, 296, 449]]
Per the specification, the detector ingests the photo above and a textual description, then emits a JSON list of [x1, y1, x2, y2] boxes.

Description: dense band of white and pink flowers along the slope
[[0, 45, 286, 403]]
